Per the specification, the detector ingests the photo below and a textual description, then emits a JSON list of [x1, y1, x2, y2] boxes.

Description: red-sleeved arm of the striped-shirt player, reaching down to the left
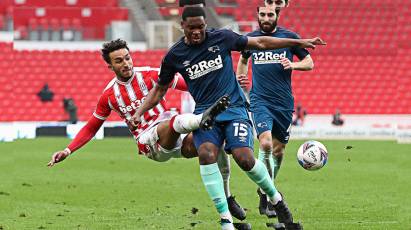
[[47, 115, 104, 167]]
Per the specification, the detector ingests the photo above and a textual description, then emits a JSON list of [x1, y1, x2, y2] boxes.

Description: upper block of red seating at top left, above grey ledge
[[13, 3, 128, 40]]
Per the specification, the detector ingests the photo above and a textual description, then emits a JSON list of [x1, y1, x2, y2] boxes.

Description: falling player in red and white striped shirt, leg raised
[[48, 39, 245, 219]]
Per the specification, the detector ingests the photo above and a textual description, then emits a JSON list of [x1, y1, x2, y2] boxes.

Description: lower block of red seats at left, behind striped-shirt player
[[5, 47, 180, 121]]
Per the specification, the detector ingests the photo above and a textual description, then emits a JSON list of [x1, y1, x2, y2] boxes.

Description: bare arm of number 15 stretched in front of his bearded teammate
[[245, 36, 327, 50]]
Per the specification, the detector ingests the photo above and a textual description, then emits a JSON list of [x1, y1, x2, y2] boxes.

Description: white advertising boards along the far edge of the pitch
[[0, 115, 411, 142]]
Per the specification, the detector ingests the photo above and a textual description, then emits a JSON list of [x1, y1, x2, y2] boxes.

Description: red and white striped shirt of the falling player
[[93, 67, 185, 138]]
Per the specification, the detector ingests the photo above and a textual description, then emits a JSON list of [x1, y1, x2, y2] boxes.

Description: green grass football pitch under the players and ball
[[0, 138, 411, 230]]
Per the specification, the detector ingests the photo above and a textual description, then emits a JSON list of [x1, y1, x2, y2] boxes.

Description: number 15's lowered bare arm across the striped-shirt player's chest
[[130, 84, 168, 127]]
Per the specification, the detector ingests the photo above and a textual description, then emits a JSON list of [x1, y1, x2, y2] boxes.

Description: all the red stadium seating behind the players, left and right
[[0, 0, 411, 121]]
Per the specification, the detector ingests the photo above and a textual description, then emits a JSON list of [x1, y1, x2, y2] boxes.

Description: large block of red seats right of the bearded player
[[227, 0, 411, 114]]
